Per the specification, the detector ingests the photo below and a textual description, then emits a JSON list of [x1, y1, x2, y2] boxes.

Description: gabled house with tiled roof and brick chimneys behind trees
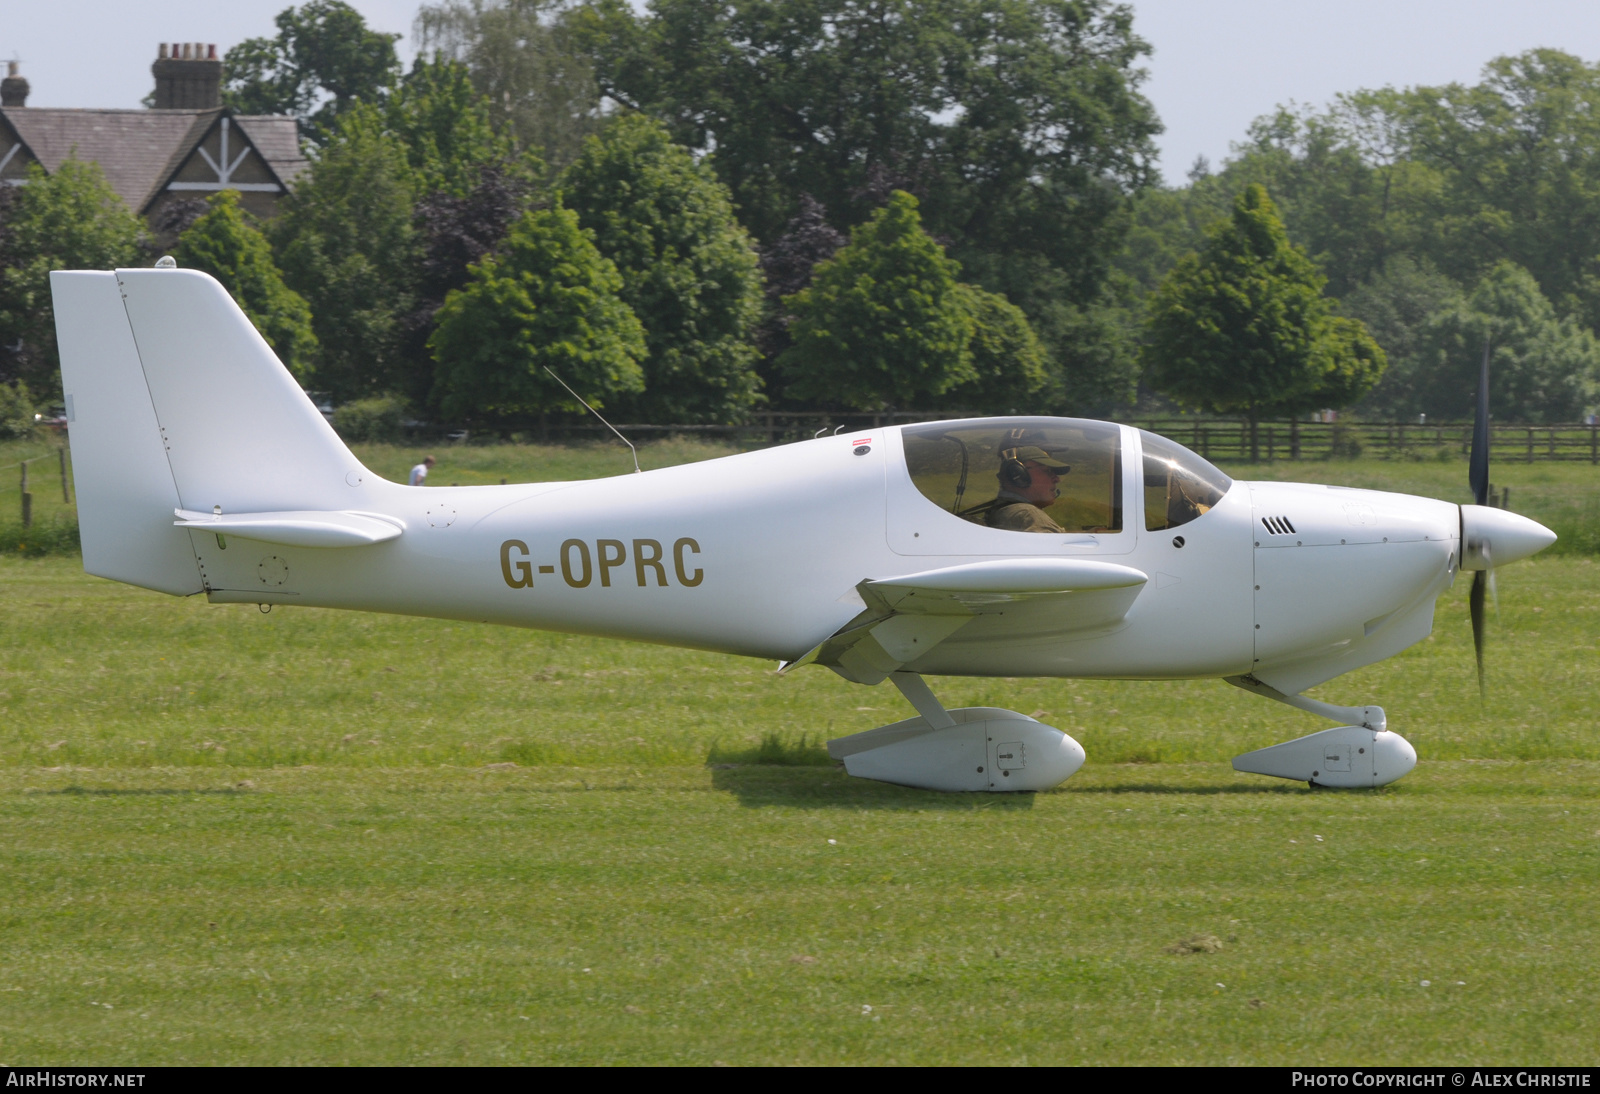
[[0, 42, 307, 243]]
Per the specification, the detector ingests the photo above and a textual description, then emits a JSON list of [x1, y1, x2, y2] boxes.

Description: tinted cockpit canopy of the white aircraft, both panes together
[[901, 417, 1232, 534]]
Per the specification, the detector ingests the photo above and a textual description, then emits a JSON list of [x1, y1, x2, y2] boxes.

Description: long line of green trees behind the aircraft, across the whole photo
[[0, 0, 1600, 430]]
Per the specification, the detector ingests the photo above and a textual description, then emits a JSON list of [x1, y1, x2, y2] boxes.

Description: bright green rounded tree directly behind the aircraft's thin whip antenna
[[429, 206, 645, 422]]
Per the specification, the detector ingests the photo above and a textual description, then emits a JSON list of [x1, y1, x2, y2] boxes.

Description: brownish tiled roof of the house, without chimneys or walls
[[0, 107, 307, 213]]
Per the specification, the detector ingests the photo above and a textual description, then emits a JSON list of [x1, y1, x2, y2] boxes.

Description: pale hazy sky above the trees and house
[[0, 0, 1600, 182]]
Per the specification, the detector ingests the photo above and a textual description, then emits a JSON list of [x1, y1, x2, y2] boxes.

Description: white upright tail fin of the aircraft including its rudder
[[50, 270, 378, 593]]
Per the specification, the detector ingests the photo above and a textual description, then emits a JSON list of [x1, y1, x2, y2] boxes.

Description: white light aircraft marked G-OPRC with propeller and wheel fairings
[[51, 269, 1555, 790]]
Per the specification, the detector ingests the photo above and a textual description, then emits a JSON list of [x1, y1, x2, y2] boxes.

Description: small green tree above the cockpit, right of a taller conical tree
[[939, 285, 1051, 414]]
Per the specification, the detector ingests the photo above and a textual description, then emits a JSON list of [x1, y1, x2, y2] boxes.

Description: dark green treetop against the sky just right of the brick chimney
[[222, 0, 400, 144]]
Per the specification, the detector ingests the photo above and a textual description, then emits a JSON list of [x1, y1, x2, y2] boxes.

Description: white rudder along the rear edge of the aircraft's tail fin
[[50, 272, 202, 595]]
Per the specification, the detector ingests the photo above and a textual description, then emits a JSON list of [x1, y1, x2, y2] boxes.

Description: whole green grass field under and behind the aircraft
[[0, 443, 1600, 1065]]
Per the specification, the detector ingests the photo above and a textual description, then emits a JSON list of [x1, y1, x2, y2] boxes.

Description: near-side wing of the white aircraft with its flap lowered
[[779, 558, 1149, 683]]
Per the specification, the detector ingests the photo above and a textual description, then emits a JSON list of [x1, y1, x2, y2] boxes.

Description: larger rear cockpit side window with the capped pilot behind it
[[902, 417, 1122, 533]]
